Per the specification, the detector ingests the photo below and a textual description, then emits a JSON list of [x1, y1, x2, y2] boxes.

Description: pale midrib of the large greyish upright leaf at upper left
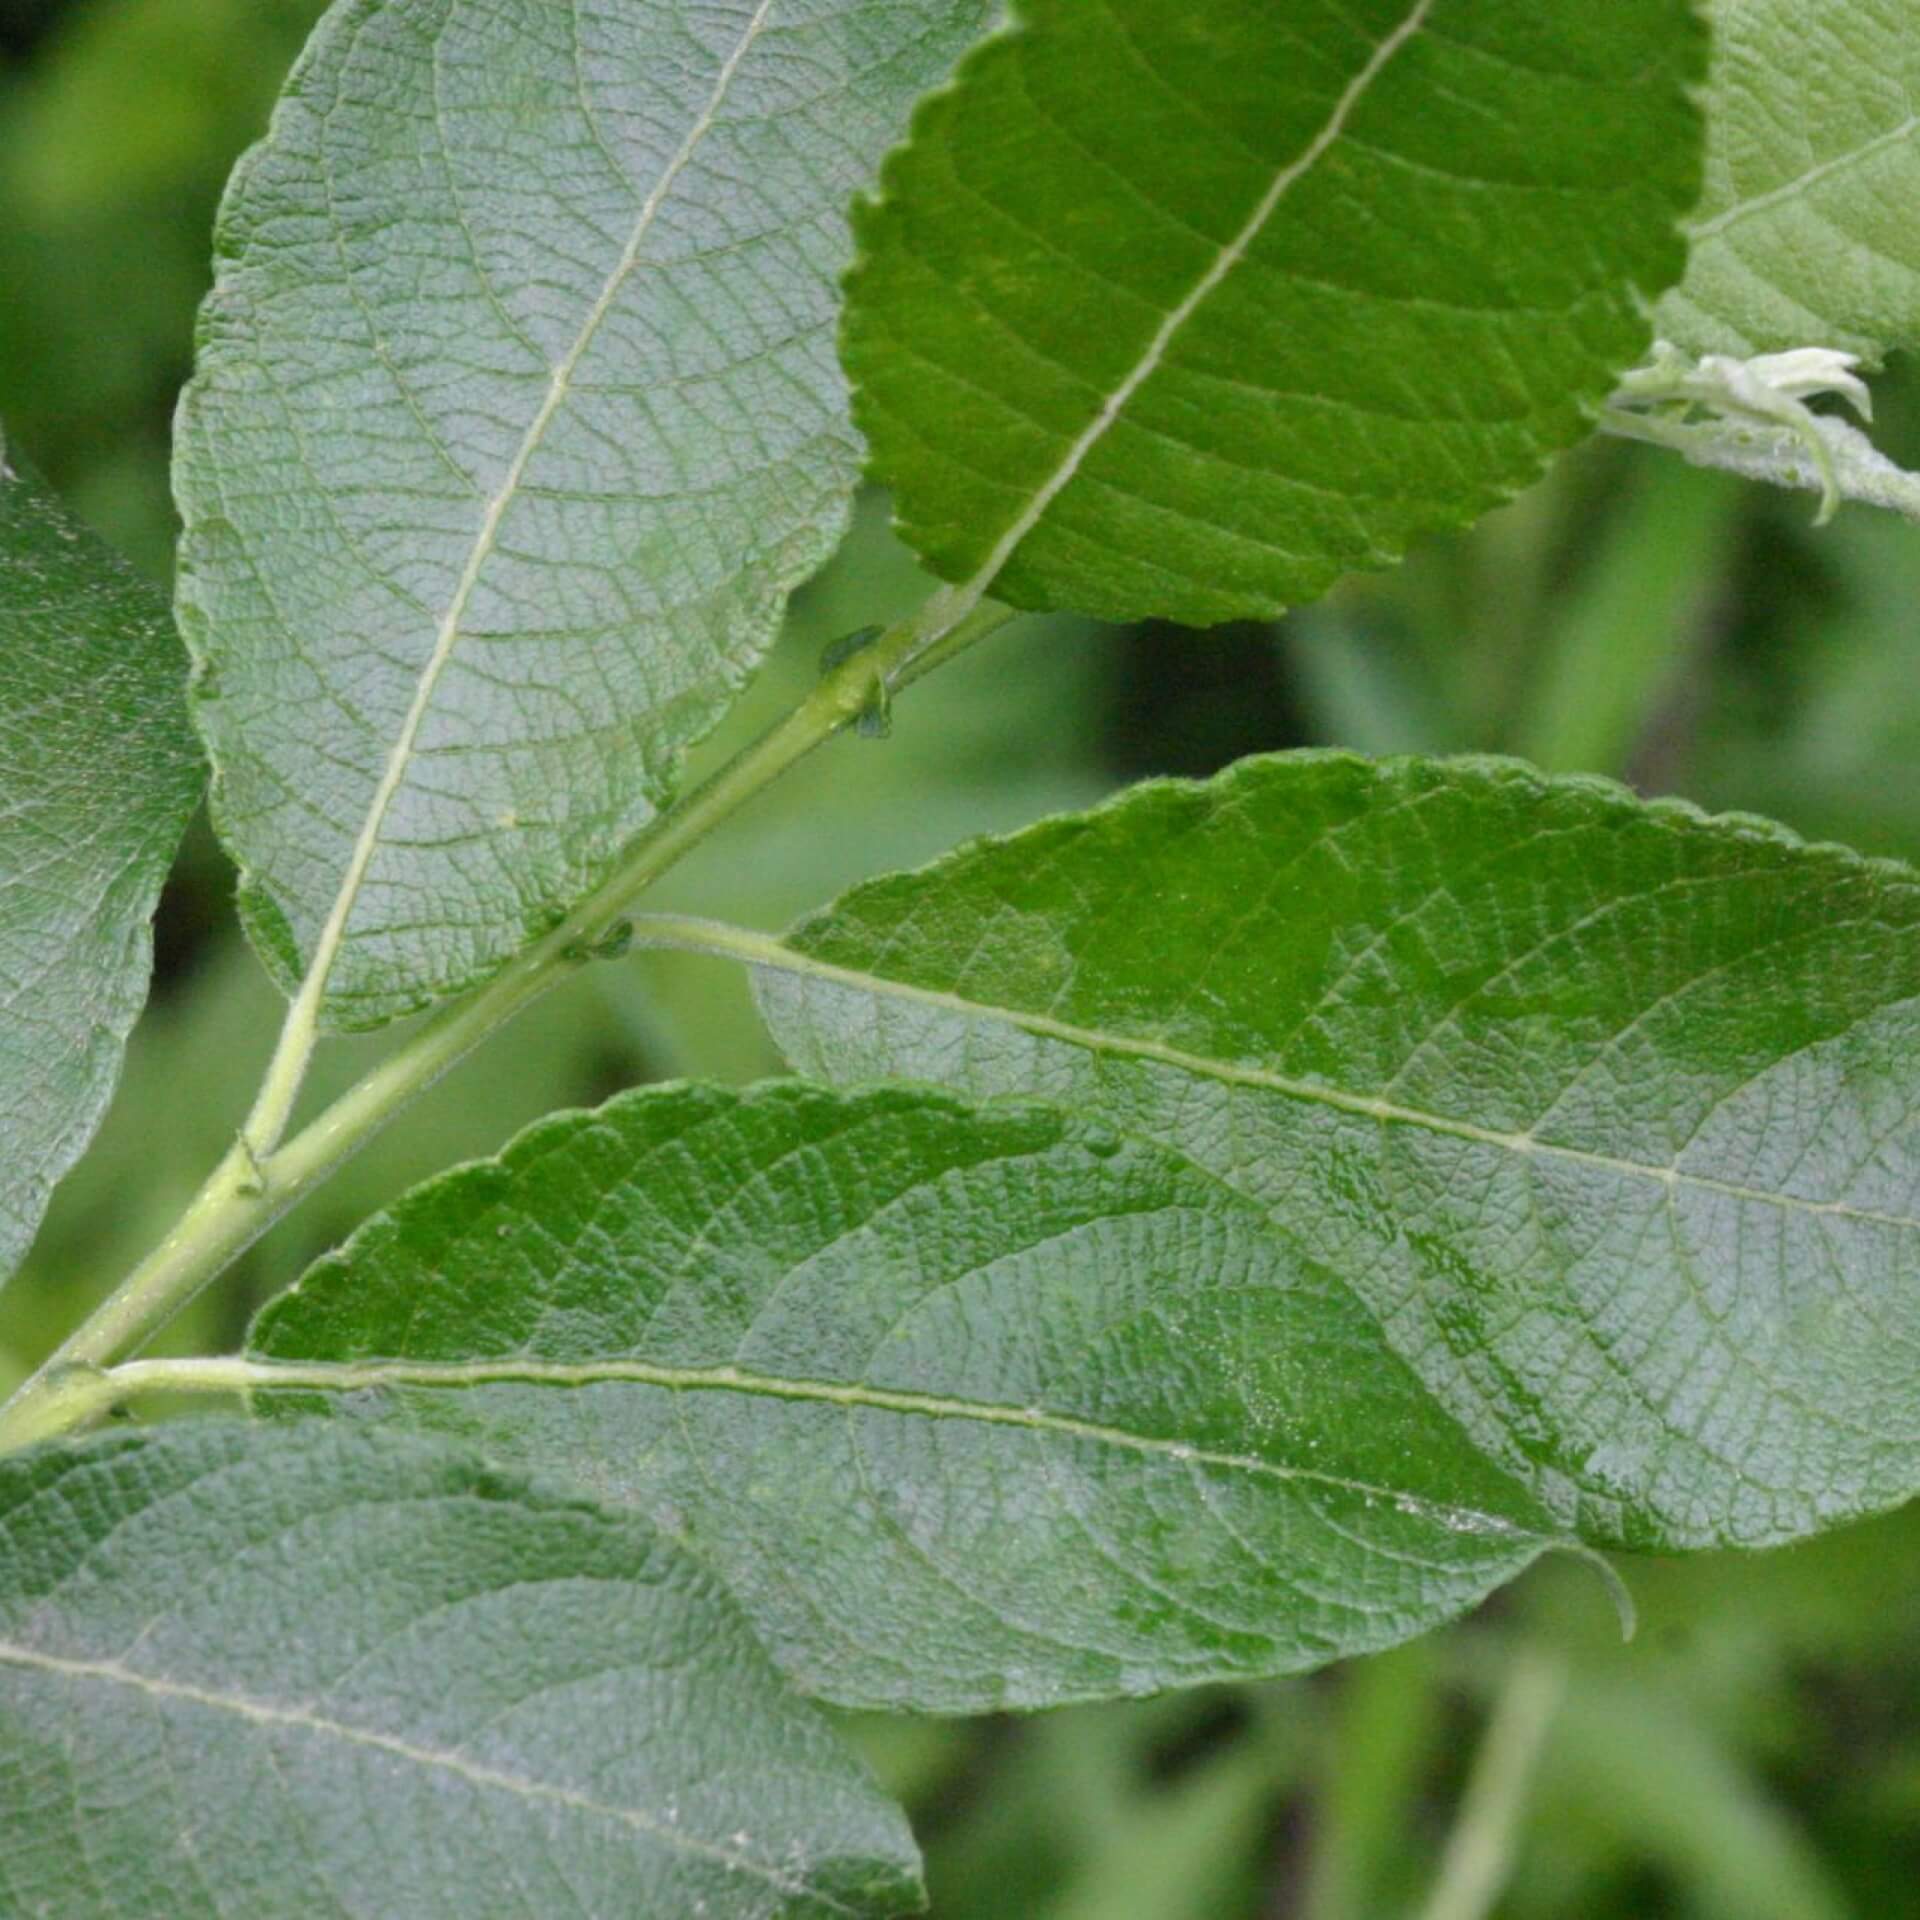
[[270, 0, 776, 1067]]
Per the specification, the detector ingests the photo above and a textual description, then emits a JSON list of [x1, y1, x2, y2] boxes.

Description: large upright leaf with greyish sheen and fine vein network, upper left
[[177, 0, 987, 1027]]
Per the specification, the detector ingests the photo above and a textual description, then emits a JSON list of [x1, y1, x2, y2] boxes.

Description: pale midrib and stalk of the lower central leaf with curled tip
[[149, 1357, 1561, 1546]]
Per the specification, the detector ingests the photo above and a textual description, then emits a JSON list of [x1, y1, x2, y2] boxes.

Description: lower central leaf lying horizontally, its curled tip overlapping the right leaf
[[252, 1085, 1553, 1711]]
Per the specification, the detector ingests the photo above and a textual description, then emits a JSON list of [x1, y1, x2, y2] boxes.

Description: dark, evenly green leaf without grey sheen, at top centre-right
[[843, 0, 1705, 624]]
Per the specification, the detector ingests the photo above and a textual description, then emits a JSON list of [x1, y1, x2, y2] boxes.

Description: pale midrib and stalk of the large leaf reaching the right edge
[[636, 916, 1920, 1231]]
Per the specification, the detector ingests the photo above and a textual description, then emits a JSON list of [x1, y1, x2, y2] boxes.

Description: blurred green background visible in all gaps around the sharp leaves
[[0, 0, 1920, 1920]]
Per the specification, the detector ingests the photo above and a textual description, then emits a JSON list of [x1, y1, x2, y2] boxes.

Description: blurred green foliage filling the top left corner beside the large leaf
[[0, 0, 323, 570]]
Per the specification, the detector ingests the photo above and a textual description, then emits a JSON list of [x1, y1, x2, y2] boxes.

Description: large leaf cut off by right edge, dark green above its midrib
[[755, 753, 1920, 1551]]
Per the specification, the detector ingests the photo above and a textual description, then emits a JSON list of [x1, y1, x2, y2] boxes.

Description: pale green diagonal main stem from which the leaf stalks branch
[[0, 595, 1014, 1453]]
